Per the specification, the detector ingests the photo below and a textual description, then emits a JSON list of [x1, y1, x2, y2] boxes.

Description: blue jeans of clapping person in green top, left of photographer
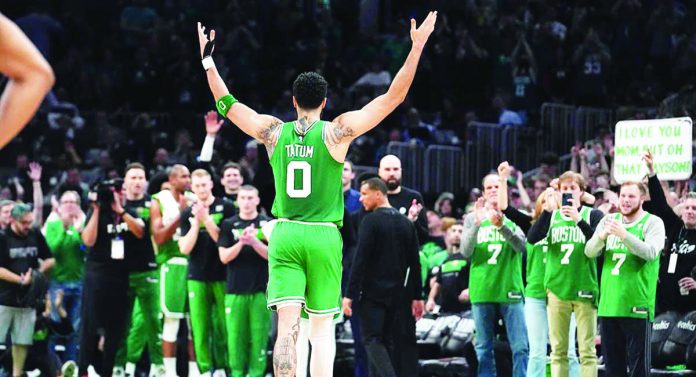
[[48, 281, 82, 362]]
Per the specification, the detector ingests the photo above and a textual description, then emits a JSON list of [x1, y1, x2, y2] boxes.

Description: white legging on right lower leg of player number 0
[[309, 314, 336, 377]]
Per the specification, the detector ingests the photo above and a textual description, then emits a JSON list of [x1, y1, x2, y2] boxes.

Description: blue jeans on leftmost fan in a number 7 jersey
[[471, 302, 529, 377]]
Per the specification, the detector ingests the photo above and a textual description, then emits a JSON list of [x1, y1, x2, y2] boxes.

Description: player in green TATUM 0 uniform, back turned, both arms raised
[[198, 12, 437, 377]]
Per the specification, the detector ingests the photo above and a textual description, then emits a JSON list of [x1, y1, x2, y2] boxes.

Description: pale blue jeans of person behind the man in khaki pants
[[524, 297, 580, 377]]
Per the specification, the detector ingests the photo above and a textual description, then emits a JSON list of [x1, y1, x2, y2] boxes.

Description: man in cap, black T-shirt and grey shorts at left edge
[[0, 203, 55, 377]]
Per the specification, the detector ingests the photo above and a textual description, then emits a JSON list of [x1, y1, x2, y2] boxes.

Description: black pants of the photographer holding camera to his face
[[78, 266, 129, 376]]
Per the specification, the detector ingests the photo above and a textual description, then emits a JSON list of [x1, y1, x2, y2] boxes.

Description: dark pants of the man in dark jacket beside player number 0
[[357, 299, 418, 377]]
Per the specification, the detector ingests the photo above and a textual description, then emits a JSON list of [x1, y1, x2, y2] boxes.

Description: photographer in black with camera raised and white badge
[[79, 179, 145, 376]]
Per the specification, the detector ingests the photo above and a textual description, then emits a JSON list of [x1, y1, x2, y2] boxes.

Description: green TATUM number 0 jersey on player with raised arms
[[270, 120, 343, 227]]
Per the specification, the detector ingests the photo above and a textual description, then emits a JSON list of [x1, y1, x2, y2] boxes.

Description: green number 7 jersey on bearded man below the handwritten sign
[[598, 213, 660, 320]]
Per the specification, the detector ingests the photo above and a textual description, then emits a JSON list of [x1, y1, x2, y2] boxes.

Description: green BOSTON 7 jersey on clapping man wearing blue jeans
[[469, 218, 523, 304]]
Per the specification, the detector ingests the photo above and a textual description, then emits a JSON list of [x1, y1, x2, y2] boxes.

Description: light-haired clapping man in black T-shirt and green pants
[[179, 169, 235, 377]]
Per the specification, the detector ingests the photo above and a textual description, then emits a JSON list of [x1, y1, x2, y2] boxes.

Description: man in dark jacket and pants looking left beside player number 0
[[343, 178, 423, 377]]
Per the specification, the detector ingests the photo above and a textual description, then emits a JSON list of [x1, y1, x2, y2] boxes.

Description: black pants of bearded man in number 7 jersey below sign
[[600, 317, 652, 377]]
